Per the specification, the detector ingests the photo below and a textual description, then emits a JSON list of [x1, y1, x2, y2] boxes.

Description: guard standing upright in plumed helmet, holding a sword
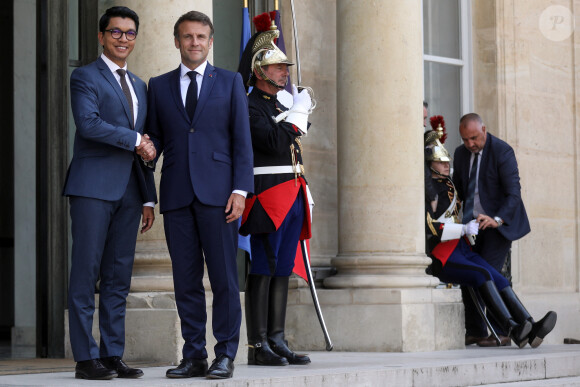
[[238, 17, 312, 366]]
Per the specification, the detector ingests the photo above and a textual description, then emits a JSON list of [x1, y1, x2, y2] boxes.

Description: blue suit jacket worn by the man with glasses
[[63, 58, 157, 203]]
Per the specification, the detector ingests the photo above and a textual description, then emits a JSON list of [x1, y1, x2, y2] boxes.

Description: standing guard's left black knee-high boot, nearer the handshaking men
[[245, 274, 288, 366]]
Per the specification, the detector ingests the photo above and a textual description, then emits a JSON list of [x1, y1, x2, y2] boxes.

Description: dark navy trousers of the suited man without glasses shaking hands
[[163, 198, 242, 359]]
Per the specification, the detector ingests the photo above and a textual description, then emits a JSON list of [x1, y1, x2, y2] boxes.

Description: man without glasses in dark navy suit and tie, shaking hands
[[147, 11, 254, 378]]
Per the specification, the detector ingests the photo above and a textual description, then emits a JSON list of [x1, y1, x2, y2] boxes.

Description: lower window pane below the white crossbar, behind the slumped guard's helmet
[[425, 62, 462, 149]]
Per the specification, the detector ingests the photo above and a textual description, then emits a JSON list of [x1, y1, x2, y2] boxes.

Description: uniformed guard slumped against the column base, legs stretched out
[[425, 128, 557, 348]]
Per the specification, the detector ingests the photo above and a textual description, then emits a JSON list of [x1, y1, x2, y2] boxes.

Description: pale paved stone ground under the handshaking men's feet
[[0, 345, 580, 387]]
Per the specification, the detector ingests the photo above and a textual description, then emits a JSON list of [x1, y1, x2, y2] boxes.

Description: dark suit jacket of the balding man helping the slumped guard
[[453, 133, 530, 241]]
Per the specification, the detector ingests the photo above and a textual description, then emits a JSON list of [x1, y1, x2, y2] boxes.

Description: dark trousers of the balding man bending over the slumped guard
[[461, 228, 512, 337]]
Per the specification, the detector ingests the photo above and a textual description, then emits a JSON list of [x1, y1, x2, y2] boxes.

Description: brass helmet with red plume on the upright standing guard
[[238, 12, 294, 89]]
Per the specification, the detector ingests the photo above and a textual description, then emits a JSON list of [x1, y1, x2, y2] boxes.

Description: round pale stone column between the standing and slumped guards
[[327, 0, 428, 288]]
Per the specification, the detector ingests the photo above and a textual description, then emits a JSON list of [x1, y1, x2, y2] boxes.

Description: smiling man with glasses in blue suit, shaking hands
[[64, 7, 157, 379]]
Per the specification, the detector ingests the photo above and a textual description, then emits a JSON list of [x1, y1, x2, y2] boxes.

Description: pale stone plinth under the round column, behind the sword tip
[[286, 288, 465, 352]]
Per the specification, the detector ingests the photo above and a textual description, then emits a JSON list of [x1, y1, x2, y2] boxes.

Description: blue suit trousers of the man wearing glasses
[[68, 170, 143, 362]]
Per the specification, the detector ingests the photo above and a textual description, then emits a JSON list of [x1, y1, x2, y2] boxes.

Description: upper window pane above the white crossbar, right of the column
[[423, 0, 461, 59]]
